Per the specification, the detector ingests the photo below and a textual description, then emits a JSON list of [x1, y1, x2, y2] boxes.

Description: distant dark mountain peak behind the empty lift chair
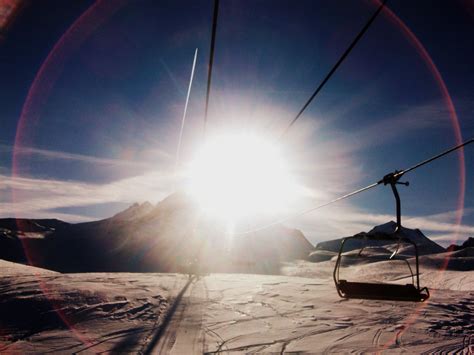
[[316, 221, 446, 255]]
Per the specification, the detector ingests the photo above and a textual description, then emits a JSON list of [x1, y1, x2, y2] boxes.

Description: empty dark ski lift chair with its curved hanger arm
[[333, 172, 430, 302]]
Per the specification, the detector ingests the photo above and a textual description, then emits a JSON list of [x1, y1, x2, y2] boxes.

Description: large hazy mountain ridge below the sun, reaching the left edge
[[0, 193, 313, 274]]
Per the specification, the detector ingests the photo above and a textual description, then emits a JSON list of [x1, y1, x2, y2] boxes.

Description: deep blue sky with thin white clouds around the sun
[[0, 0, 474, 245]]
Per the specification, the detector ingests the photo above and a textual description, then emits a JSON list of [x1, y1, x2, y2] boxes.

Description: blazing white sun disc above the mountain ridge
[[188, 134, 296, 222]]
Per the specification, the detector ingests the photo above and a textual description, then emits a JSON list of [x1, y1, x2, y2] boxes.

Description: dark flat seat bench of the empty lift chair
[[336, 280, 429, 302]]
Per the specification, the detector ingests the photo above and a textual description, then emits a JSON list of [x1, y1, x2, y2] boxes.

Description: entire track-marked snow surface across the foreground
[[0, 261, 474, 354]]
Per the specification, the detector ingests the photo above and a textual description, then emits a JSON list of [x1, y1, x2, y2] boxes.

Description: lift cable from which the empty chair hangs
[[237, 138, 474, 235]]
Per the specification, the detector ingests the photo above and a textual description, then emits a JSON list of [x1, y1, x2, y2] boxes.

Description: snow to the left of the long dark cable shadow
[[0, 261, 187, 353]]
